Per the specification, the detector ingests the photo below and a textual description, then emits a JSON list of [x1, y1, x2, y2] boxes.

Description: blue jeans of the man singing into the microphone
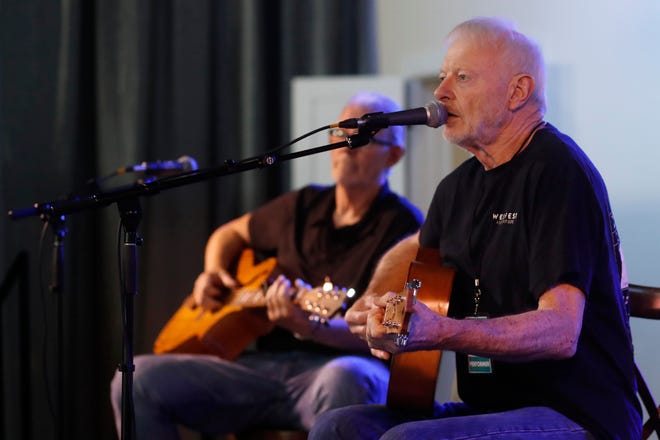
[[309, 402, 595, 440]]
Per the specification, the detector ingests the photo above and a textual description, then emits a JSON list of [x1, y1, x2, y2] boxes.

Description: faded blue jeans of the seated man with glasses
[[111, 352, 389, 440]]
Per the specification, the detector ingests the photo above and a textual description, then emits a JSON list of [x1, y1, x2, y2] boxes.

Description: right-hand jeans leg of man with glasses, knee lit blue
[[287, 356, 389, 430]]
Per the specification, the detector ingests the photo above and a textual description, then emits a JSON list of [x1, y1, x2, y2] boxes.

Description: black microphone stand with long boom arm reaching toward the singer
[[8, 130, 370, 440]]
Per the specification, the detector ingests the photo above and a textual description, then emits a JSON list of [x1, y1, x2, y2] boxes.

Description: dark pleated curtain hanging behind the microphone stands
[[0, 0, 376, 439]]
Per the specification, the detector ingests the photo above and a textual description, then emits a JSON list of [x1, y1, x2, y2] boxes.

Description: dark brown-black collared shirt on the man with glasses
[[249, 185, 423, 352]]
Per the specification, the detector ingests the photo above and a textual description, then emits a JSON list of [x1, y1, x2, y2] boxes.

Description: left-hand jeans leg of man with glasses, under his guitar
[[112, 354, 290, 440]]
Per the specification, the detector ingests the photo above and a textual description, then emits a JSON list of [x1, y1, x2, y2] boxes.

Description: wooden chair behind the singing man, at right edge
[[629, 284, 660, 439]]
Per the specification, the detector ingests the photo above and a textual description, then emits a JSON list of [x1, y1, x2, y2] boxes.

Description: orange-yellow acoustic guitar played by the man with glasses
[[153, 249, 348, 360]]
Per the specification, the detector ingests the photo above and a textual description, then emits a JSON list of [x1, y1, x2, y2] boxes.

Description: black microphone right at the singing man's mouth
[[332, 100, 447, 130]]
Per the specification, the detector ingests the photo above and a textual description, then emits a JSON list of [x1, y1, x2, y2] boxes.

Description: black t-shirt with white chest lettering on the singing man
[[420, 125, 641, 438]]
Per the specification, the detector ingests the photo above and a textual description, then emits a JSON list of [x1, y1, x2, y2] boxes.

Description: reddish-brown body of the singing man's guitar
[[387, 248, 455, 415]]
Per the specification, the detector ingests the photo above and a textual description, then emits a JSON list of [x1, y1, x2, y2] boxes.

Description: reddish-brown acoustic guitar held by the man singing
[[383, 248, 455, 415]]
